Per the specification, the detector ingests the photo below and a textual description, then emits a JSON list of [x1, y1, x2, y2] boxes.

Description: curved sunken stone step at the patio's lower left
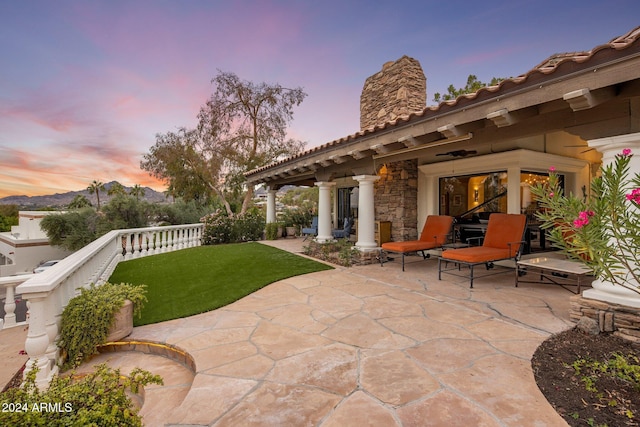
[[77, 341, 195, 426]]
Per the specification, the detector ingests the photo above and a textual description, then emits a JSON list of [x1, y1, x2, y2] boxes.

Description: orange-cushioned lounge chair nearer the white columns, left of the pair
[[379, 215, 453, 271]]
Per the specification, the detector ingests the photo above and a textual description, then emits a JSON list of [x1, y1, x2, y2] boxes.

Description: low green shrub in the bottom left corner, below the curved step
[[0, 364, 163, 427]]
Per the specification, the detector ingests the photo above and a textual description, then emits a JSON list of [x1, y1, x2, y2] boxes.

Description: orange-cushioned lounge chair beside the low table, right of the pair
[[438, 213, 527, 288]]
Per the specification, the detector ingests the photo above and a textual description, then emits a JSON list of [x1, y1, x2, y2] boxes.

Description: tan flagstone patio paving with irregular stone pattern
[[2, 239, 573, 427]]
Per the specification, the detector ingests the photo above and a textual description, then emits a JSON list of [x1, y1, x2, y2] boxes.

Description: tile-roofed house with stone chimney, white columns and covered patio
[[246, 27, 640, 250]]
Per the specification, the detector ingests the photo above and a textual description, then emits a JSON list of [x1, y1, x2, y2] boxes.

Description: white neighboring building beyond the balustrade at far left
[[0, 211, 71, 277]]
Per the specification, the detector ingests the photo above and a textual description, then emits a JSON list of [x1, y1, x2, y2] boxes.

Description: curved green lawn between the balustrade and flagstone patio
[[109, 242, 332, 326]]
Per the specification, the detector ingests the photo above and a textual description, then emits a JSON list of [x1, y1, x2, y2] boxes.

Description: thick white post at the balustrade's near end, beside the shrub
[[24, 294, 58, 388]]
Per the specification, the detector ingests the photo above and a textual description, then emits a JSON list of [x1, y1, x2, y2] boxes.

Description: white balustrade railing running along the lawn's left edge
[[15, 224, 203, 385]]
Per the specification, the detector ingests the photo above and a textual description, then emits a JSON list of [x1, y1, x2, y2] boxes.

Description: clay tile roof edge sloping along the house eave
[[245, 26, 640, 176]]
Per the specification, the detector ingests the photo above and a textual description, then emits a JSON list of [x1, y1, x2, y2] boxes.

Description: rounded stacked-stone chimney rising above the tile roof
[[360, 55, 427, 130]]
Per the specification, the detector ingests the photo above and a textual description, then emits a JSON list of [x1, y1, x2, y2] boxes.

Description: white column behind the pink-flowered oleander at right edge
[[582, 133, 640, 307]]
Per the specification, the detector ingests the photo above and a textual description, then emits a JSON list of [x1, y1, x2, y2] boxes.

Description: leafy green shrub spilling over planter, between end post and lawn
[[58, 283, 146, 369]]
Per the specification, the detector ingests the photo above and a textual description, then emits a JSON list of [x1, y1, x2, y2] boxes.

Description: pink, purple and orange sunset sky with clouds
[[0, 0, 640, 198]]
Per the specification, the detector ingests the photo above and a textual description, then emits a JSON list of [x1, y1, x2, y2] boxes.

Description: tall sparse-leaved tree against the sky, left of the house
[[140, 72, 306, 215]]
